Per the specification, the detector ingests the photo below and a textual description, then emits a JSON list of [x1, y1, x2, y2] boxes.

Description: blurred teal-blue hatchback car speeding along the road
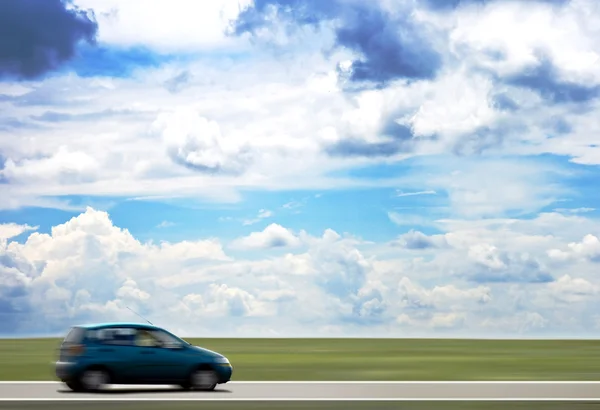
[[56, 323, 233, 391]]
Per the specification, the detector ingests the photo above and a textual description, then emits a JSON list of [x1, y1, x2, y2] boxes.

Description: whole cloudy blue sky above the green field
[[0, 0, 600, 338]]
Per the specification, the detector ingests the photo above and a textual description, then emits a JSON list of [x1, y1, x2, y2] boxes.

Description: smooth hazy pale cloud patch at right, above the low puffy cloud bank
[[388, 156, 576, 221]]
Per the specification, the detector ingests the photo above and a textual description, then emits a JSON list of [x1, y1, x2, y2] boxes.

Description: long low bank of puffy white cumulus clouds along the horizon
[[0, 209, 599, 336]]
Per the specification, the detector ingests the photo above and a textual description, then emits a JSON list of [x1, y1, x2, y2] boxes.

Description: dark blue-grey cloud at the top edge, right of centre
[[231, 0, 442, 85]]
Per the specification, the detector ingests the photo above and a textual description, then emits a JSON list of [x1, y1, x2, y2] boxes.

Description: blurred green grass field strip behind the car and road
[[0, 339, 600, 381]]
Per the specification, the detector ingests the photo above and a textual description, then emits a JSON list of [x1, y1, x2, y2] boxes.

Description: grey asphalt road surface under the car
[[0, 382, 600, 401]]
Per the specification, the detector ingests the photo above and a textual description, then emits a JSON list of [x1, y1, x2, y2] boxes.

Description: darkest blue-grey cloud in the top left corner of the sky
[[0, 0, 98, 79]]
